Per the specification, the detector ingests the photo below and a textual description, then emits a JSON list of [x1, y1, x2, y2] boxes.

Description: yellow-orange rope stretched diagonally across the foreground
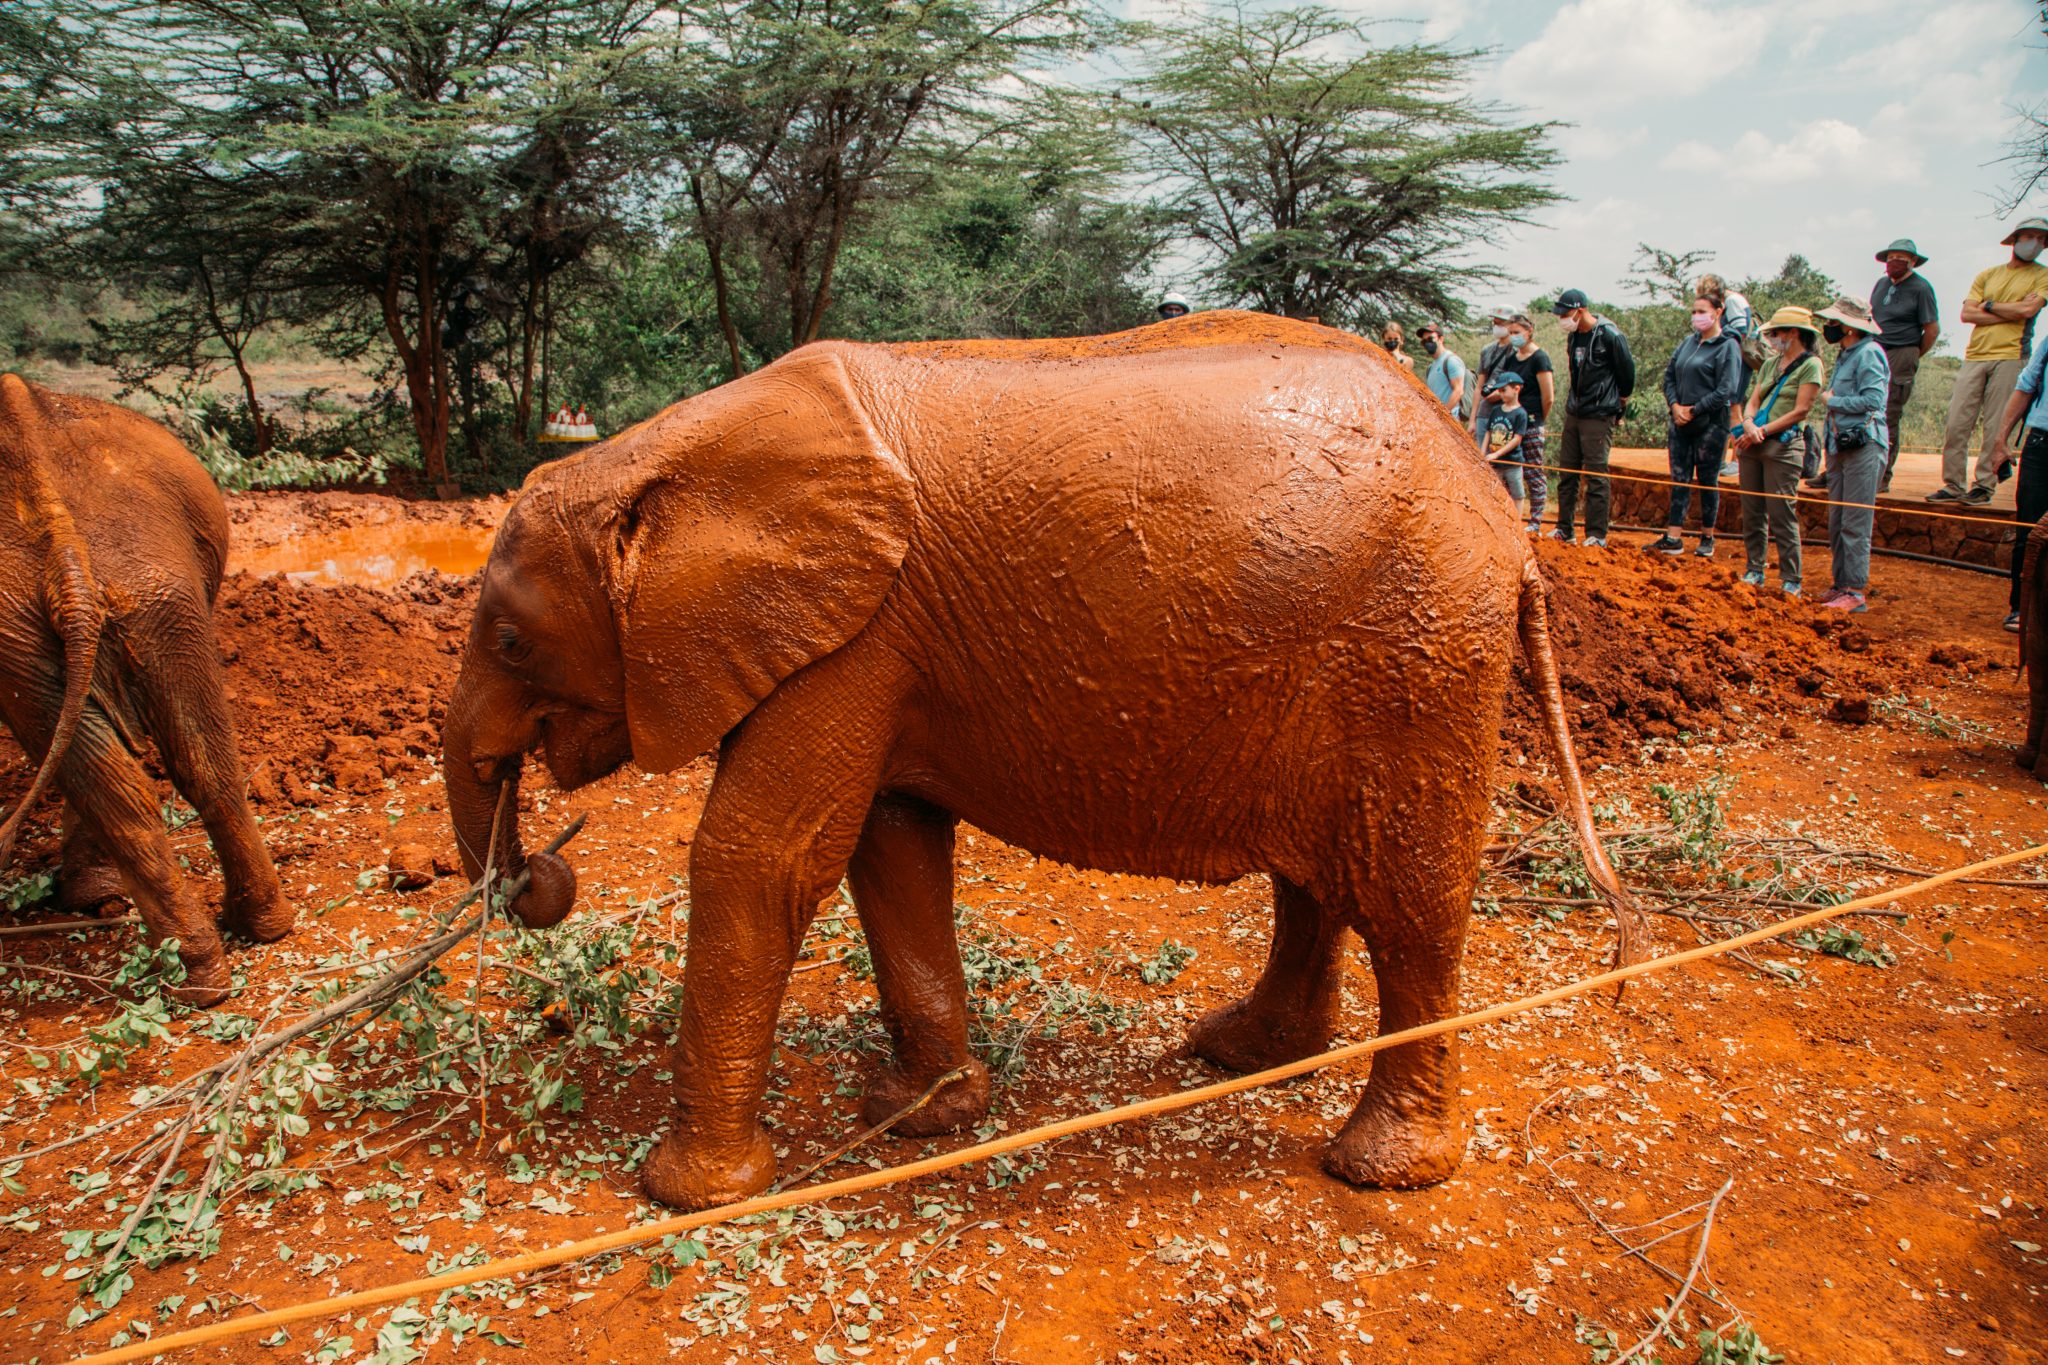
[[74, 843, 2048, 1365]]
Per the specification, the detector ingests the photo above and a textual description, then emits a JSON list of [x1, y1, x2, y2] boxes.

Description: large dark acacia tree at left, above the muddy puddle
[[49, 0, 659, 483]]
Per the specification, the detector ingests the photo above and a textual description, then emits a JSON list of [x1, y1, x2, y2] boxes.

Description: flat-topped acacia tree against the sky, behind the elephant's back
[[1116, 2, 1559, 327]]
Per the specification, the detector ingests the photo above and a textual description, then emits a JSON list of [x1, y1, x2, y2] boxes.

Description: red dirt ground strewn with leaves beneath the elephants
[[0, 495, 2048, 1365]]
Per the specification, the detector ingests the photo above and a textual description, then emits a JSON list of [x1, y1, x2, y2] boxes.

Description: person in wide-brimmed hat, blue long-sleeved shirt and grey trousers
[[1815, 299, 1892, 612]]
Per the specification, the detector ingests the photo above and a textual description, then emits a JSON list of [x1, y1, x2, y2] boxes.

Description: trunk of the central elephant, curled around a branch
[[442, 675, 575, 929]]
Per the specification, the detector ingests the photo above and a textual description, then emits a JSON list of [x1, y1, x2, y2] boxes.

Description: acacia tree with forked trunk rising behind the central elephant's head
[[670, 0, 1096, 375]]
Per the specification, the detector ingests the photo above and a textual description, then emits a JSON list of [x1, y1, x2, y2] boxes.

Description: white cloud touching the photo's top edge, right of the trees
[[1509, 0, 1772, 106]]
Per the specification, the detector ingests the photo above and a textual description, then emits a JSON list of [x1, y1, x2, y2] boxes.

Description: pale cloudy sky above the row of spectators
[[1135, 0, 2048, 341]]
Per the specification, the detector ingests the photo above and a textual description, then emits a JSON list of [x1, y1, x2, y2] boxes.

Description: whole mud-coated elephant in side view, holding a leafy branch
[[444, 313, 1636, 1207]]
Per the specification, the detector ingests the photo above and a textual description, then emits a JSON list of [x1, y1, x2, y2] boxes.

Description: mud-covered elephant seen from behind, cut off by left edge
[[0, 375, 293, 1005]]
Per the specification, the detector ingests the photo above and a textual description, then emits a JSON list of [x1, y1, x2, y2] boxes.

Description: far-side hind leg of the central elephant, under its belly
[[1188, 874, 1346, 1072]]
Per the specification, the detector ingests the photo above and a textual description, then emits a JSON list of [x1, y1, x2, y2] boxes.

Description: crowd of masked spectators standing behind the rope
[[1294, 217, 2048, 630]]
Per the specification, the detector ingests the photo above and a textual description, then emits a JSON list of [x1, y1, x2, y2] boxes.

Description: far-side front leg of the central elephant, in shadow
[[846, 796, 989, 1138]]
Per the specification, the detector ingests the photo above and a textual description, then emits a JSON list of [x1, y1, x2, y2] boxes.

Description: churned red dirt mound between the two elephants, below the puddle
[[215, 573, 477, 806]]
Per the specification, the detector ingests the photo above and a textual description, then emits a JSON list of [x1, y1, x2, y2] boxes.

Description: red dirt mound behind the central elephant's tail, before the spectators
[[1501, 540, 1925, 763]]
